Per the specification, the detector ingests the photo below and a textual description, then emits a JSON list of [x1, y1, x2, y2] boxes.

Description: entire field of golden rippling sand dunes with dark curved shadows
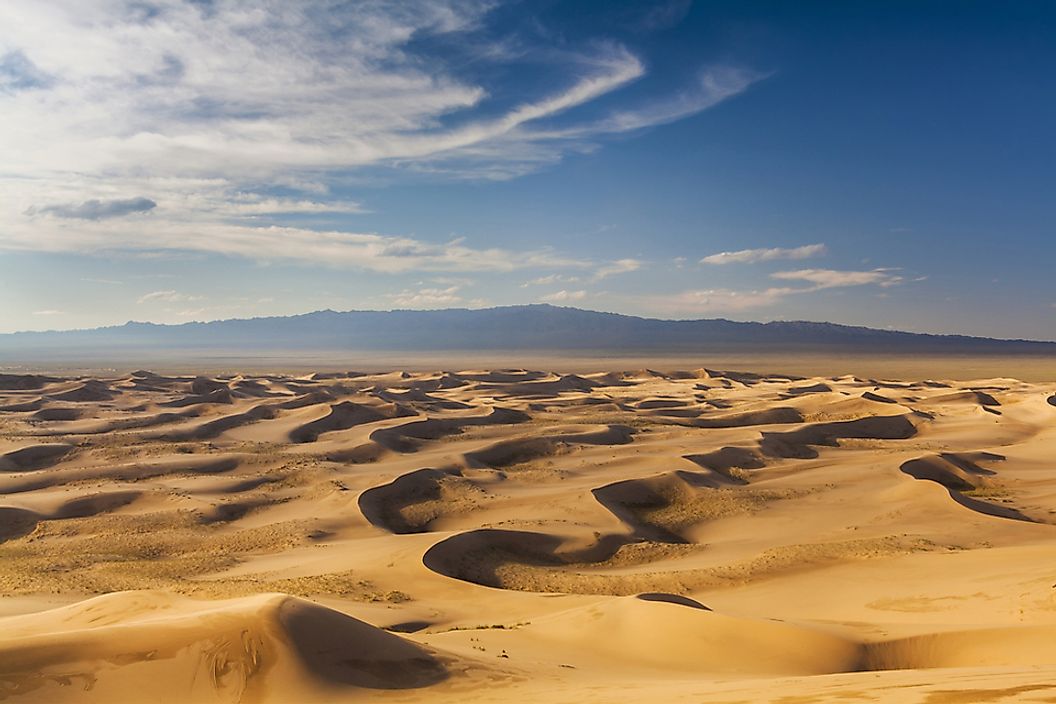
[[0, 369, 1056, 704]]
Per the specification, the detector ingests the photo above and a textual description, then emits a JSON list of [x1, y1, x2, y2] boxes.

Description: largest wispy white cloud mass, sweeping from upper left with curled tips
[[0, 0, 759, 273]]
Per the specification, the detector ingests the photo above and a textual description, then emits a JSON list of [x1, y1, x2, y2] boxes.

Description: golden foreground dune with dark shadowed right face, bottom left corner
[[0, 592, 447, 702]]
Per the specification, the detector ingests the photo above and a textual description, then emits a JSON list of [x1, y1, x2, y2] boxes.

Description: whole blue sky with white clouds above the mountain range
[[0, 0, 1056, 340]]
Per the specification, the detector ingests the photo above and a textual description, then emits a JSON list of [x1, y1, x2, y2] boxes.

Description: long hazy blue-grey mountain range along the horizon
[[0, 305, 1056, 362]]
